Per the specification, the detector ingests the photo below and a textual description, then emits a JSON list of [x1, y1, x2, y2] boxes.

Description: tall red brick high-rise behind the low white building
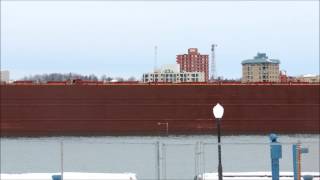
[[177, 48, 209, 82]]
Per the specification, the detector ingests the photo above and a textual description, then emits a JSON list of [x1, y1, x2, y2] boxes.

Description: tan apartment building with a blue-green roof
[[241, 53, 280, 83]]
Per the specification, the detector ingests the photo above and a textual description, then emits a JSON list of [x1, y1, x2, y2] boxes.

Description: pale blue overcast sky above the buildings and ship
[[1, 1, 319, 79]]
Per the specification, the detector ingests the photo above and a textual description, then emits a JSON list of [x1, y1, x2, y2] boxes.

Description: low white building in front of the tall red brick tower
[[142, 64, 205, 83]]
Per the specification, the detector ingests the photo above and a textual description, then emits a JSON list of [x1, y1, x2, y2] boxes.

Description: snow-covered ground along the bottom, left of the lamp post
[[0, 172, 137, 180]]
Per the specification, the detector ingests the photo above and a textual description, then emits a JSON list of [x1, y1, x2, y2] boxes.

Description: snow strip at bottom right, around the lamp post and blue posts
[[197, 172, 320, 180]]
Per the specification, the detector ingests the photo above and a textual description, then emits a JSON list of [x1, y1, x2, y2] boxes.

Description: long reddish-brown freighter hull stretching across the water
[[1, 84, 320, 136]]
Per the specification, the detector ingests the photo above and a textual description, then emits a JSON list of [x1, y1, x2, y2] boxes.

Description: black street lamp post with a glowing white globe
[[213, 103, 224, 180]]
